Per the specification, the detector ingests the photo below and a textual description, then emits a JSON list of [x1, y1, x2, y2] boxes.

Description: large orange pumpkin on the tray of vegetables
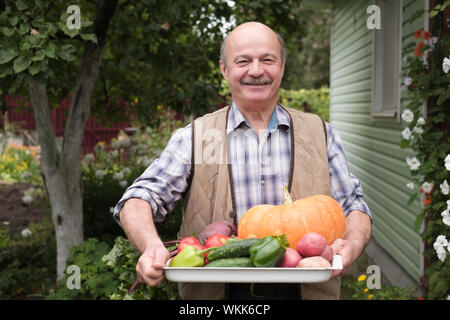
[[238, 187, 345, 249]]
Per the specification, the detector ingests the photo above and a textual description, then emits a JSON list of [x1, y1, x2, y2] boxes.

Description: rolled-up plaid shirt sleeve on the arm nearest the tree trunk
[[113, 124, 192, 226]]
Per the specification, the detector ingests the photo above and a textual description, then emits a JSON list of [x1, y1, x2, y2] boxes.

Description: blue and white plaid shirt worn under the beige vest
[[113, 103, 372, 224]]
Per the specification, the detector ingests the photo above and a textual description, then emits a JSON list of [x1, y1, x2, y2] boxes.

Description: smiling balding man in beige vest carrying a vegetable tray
[[114, 22, 372, 299]]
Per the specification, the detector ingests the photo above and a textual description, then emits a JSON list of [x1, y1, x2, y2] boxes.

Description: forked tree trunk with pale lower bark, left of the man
[[29, 0, 117, 279]]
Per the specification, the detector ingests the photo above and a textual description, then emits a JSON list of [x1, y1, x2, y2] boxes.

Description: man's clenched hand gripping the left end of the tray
[[136, 241, 169, 287]]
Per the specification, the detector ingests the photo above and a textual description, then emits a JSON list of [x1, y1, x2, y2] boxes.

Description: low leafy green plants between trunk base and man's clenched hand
[[47, 237, 179, 300]]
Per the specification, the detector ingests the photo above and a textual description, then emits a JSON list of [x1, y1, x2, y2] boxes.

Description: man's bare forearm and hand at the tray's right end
[[331, 210, 372, 277]]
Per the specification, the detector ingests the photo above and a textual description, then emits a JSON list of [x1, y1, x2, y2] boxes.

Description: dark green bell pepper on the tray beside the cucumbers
[[249, 235, 288, 268]]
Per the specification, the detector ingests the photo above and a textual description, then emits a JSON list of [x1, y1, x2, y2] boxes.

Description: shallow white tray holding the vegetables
[[164, 255, 342, 283]]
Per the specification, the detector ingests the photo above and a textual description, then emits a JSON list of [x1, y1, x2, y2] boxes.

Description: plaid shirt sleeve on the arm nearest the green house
[[326, 123, 373, 222]]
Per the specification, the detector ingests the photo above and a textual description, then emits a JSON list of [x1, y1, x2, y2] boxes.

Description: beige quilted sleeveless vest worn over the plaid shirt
[[178, 107, 340, 300]]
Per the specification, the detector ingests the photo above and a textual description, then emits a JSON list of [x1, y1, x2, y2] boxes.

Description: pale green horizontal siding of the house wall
[[330, 0, 425, 282]]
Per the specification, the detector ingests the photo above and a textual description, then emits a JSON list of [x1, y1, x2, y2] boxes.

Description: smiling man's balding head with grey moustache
[[220, 23, 284, 105]]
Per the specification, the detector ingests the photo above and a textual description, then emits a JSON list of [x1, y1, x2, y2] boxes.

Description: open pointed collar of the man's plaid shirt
[[227, 101, 290, 134]]
